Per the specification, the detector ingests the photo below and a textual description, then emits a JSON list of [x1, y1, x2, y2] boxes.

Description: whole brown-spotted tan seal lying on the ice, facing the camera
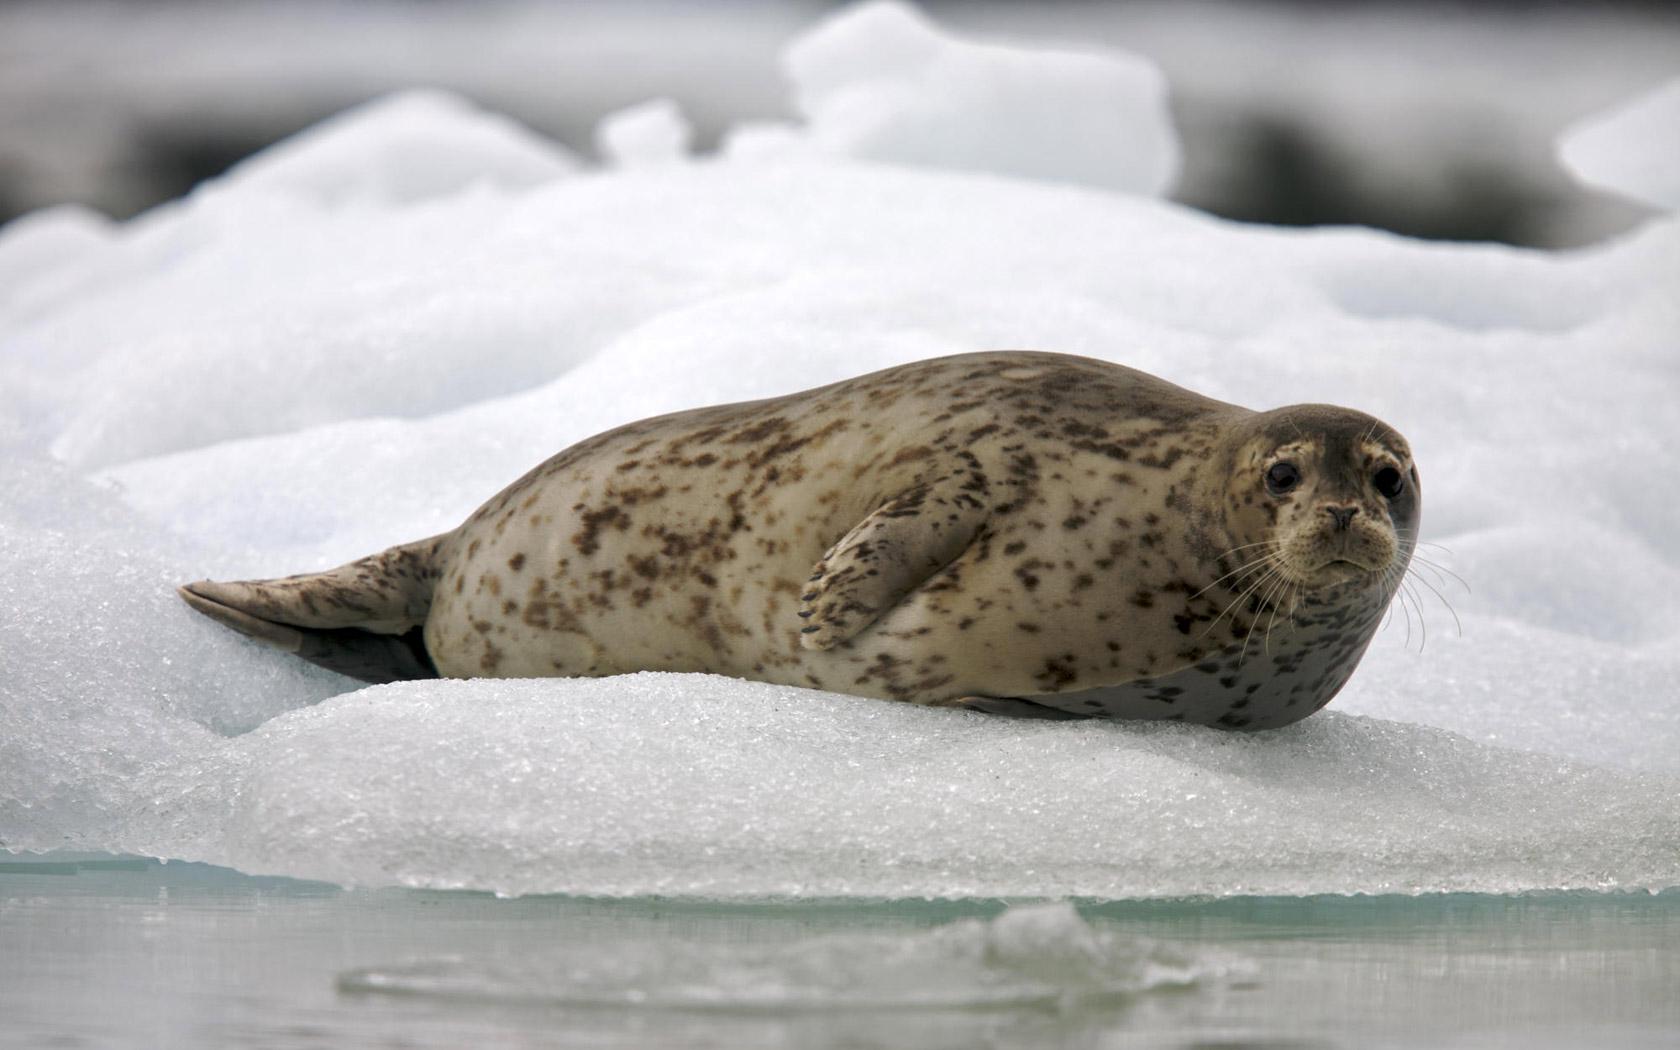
[[180, 353, 1421, 729]]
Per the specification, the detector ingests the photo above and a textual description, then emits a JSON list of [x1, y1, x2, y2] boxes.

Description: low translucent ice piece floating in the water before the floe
[[338, 904, 1250, 1007]]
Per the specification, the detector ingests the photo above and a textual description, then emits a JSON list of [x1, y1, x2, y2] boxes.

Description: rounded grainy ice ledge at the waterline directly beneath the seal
[[199, 674, 1680, 899]]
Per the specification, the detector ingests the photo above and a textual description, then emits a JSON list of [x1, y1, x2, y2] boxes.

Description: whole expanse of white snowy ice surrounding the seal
[[0, 8, 1680, 897]]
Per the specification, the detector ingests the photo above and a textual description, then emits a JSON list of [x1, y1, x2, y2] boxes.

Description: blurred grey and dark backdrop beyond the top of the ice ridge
[[0, 0, 1680, 247]]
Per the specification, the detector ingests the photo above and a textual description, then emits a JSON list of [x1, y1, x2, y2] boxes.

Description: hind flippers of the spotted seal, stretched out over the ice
[[178, 536, 444, 682]]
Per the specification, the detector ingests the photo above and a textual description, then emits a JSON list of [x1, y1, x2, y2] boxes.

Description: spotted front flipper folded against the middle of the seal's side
[[800, 477, 986, 648]]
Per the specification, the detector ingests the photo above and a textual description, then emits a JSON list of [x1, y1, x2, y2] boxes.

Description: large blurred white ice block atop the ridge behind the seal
[[781, 0, 1179, 195]]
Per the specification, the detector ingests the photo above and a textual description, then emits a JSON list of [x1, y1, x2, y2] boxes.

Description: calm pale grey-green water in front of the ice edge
[[0, 857, 1680, 1048]]
